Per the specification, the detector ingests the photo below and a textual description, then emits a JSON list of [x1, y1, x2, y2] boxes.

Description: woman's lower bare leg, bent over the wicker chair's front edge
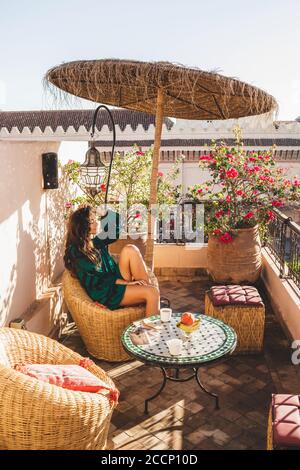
[[121, 286, 160, 317]]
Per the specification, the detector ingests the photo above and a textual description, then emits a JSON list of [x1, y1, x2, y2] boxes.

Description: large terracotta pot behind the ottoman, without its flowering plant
[[207, 225, 262, 284]]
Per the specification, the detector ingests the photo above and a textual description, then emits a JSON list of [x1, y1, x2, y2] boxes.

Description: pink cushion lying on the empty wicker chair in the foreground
[[14, 358, 119, 401]]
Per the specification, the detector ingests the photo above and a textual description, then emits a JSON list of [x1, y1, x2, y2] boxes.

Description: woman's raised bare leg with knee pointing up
[[119, 245, 150, 284]]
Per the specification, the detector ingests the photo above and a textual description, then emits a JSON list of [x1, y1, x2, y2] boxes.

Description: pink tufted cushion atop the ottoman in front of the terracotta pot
[[210, 285, 263, 306]]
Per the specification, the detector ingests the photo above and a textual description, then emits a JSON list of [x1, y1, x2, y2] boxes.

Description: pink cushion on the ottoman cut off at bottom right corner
[[272, 395, 300, 447]]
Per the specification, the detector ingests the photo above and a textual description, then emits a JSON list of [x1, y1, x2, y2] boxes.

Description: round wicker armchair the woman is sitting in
[[62, 269, 158, 362]]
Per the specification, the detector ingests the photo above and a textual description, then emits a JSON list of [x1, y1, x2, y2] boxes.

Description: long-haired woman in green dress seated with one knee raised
[[64, 206, 160, 316]]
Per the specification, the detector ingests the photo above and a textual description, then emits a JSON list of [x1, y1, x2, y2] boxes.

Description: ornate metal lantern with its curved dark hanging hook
[[79, 105, 116, 203]]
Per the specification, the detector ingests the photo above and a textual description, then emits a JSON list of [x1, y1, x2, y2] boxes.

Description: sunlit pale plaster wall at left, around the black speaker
[[0, 141, 72, 333]]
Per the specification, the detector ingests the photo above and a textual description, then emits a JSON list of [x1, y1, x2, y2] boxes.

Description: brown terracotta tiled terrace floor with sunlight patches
[[58, 281, 300, 450]]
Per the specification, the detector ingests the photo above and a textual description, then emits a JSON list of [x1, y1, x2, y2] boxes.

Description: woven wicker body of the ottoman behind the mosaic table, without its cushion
[[205, 291, 265, 354]]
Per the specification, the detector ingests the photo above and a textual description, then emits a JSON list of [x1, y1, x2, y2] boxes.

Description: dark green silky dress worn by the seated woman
[[69, 210, 126, 310]]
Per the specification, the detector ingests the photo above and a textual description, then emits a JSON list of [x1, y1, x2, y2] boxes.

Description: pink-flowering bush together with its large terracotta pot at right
[[189, 130, 300, 283]]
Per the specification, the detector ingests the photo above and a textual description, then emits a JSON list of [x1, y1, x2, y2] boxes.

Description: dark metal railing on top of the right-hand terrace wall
[[265, 209, 300, 288]]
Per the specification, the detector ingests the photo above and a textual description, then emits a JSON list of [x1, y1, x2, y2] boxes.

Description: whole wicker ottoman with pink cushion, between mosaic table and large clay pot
[[205, 285, 265, 354]]
